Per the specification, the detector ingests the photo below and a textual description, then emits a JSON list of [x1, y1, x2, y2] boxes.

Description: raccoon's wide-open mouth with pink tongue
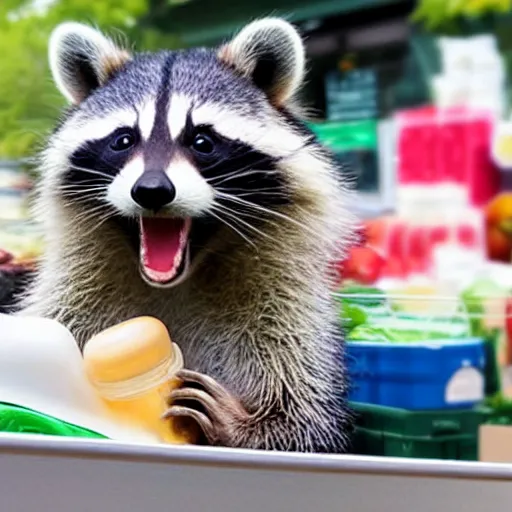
[[140, 217, 190, 283]]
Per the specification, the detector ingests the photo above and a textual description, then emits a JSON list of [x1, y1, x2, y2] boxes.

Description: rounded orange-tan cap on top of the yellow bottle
[[83, 317, 182, 394]]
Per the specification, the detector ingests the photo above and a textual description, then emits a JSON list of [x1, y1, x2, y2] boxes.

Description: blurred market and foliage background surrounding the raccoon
[[4, 0, 512, 459]]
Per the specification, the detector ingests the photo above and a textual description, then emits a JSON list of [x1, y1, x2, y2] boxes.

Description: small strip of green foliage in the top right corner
[[413, 0, 512, 31]]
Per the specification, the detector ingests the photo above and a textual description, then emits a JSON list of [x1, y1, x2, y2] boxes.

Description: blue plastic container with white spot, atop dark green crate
[[347, 338, 485, 410]]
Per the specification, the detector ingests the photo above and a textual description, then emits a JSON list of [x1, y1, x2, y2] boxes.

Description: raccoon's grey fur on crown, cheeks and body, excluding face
[[22, 19, 353, 452]]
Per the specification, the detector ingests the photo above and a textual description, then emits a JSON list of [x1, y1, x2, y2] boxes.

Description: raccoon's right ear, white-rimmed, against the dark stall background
[[218, 18, 305, 107]]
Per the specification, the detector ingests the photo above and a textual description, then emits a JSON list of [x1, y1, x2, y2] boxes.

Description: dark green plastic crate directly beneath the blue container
[[352, 403, 490, 460]]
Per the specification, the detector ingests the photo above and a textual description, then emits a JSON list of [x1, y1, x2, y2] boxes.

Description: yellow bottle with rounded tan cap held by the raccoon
[[83, 317, 197, 444]]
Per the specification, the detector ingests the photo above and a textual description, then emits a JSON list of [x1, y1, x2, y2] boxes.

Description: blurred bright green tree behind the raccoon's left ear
[[0, 0, 177, 158]]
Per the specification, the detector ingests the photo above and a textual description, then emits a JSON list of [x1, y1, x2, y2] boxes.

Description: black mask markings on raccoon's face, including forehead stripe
[[61, 50, 292, 274]]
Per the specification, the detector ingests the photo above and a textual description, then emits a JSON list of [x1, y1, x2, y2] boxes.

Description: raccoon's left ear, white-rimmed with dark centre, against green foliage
[[48, 22, 131, 104]]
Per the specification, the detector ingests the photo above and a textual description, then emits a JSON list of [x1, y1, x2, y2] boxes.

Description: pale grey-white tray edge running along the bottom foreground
[[0, 434, 512, 512]]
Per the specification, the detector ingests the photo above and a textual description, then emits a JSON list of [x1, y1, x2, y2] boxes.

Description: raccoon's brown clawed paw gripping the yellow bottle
[[164, 370, 249, 447]]
